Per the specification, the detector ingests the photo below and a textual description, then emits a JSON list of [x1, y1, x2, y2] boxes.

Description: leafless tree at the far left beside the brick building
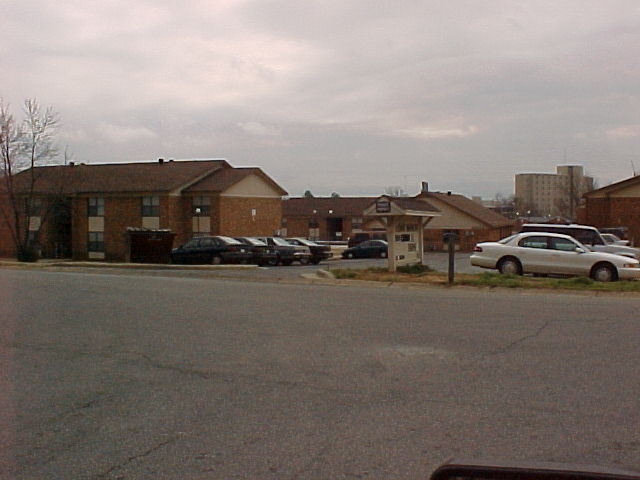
[[0, 99, 59, 261]]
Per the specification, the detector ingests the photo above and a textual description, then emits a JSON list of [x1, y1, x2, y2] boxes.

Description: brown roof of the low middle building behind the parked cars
[[282, 197, 376, 217]]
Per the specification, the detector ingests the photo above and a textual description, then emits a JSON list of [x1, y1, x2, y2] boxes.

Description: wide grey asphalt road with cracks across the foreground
[[0, 269, 640, 479]]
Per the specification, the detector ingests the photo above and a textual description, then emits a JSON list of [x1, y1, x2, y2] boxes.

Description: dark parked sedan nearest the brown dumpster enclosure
[[171, 235, 252, 265]]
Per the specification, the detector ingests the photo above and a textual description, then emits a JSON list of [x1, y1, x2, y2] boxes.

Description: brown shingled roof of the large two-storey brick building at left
[[7, 160, 286, 195]]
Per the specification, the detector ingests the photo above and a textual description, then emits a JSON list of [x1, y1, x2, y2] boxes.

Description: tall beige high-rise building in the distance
[[515, 165, 594, 219]]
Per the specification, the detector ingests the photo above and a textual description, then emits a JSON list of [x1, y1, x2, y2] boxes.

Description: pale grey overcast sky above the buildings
[[5, 0, 640, 198]]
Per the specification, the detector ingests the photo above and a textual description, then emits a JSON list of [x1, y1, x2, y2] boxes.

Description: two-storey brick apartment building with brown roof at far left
[[0, 160, 287, 261]]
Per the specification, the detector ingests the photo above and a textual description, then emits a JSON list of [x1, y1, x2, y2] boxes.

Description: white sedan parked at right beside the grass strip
[[471, 232, 640, 282]]
